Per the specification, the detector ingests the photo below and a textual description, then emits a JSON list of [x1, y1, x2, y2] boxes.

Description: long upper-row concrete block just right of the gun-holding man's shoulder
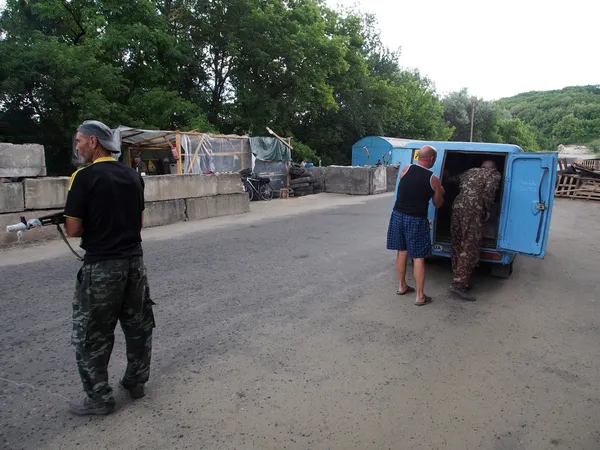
[[144, 174, 217, 202]]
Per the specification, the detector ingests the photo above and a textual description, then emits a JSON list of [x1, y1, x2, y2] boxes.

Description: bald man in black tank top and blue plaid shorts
[[387, 145, 444, 306]]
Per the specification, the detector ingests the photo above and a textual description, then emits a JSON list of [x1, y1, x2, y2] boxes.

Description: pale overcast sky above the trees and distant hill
[[326, 0, 600, 100]]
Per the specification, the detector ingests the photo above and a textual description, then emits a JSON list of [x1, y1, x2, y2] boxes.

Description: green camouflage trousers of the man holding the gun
[[71, 256, 155, 404]]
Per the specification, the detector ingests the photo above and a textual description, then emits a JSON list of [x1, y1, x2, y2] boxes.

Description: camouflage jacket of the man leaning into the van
[[448, 167, 502, 213]]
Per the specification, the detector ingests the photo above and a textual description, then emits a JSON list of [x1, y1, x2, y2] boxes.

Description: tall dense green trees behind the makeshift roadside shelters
[[0, 0, 452, 174]]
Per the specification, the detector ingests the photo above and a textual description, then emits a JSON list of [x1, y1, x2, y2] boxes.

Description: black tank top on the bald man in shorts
[[394, 164, 434, 218]]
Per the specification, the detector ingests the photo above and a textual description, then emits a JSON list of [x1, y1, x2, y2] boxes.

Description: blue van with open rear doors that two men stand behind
[[372, 140, 558, 278]]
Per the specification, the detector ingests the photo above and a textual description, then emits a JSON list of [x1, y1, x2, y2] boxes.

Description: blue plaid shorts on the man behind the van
[[387, 210, 431, 258]]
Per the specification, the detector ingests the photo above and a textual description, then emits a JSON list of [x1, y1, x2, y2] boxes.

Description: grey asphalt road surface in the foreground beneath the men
[[0, 195, 600, 450]]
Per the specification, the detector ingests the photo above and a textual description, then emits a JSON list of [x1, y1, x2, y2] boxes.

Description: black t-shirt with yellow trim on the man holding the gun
[[65, 157, 144, 263]]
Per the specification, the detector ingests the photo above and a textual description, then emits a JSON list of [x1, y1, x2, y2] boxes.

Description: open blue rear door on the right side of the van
[[498, 153, 558, 258]]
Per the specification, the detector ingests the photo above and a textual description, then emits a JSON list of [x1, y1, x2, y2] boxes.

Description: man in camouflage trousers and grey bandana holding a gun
[[64, 121, 155, 415]]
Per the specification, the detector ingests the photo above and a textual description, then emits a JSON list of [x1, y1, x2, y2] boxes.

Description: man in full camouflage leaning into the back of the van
[[447, 160, 501, 301]]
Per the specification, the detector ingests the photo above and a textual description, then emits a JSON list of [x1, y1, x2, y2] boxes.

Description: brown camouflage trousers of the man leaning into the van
[[451, 208, 483, 288]]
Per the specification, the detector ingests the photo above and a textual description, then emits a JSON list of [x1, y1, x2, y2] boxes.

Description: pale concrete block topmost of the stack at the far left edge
[[0, 142, 46, 178]]
